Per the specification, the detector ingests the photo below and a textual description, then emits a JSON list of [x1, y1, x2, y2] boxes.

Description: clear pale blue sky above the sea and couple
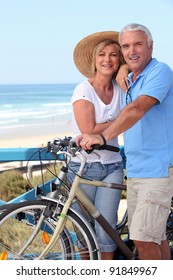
[[0, 0, 173, 84]]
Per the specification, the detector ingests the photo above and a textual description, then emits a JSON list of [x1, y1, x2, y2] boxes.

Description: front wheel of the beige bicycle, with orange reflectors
[[0, 200, 99, 260]]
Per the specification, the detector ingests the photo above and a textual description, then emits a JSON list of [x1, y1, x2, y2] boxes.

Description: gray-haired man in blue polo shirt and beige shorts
[[76, 24, 173, 260]]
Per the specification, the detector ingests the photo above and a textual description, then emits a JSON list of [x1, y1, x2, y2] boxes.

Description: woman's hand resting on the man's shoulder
[[116, 64, 129, 92]]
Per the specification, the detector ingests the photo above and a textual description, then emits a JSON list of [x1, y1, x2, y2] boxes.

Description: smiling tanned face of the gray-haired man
[[120, 30, 153, 79]]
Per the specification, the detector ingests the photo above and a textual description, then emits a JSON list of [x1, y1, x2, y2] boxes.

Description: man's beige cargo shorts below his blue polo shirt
[[127, 168, 173, 245]]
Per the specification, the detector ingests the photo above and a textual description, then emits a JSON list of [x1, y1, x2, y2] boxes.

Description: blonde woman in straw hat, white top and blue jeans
[[68, 31, 128, 259]]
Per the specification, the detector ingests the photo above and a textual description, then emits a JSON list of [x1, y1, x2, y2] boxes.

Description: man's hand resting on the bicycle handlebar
[[76, 134, 104, 150]]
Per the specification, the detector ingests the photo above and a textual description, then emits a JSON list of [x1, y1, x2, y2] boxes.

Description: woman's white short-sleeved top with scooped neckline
[[71, 80, 122, 164]]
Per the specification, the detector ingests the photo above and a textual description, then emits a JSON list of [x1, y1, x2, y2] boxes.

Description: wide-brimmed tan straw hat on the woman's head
[[73, 31, 119, 78]]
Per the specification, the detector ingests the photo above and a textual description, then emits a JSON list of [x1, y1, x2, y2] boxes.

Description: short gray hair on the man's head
[[119, 23, 153, 47]]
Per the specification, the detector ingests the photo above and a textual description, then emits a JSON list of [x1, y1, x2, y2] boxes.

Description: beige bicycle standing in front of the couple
[[0, 137, 173, 260]]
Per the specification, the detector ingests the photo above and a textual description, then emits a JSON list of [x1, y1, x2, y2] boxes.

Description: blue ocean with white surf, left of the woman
[[0, 84, 76, 132]]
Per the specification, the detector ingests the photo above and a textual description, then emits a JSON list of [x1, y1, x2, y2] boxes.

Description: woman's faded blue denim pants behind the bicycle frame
[[68, 162, 123, 252]]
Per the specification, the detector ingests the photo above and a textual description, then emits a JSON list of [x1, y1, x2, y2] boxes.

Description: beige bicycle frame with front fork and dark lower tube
[[37, 149, 134, 259]]
